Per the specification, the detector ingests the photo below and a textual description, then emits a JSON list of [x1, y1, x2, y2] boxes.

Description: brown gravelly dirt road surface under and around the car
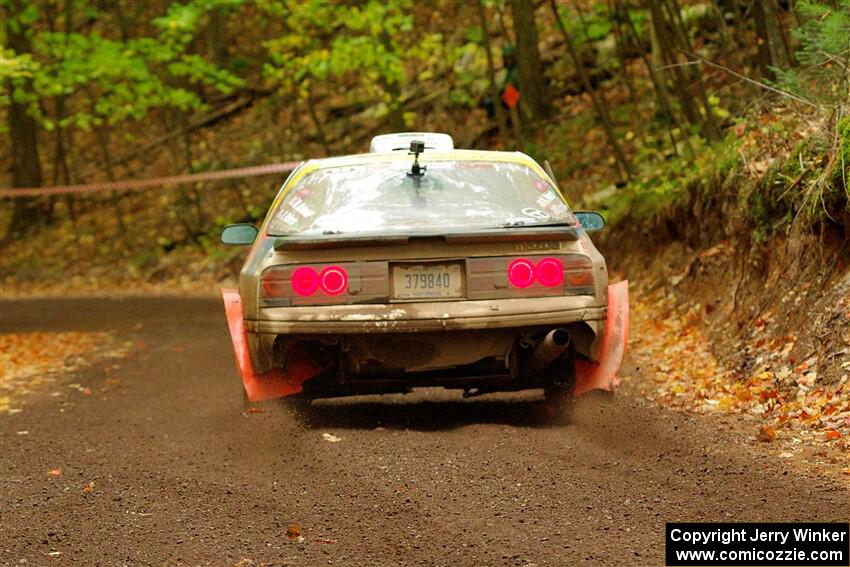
[[0, 298, 850, 566]]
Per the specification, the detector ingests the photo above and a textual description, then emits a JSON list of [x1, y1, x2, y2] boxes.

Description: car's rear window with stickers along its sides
[[268, 159, 575, 236]]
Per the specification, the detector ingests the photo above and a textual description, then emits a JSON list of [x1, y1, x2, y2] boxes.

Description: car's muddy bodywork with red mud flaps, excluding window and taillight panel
[[223, 143, 628, 400]]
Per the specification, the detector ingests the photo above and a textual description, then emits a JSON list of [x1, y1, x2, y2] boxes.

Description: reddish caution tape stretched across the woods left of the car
[[0, 161, 300, 199]]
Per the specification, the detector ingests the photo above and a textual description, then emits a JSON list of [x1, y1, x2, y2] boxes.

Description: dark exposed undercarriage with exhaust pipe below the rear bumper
[[273, 323, 594, 398]]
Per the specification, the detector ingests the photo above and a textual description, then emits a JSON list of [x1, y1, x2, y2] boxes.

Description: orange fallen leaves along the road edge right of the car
[[624, 292, 850, 474]]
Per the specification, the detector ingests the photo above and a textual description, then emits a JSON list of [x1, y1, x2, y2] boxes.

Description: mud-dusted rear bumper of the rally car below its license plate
[[245, 296, 607, 335]]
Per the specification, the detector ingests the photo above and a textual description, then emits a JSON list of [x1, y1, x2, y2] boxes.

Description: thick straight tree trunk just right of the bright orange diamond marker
[[511, 0, 552, 120]]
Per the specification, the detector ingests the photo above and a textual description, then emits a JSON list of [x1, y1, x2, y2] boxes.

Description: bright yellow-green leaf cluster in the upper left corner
[[0, 0, 242, 130]]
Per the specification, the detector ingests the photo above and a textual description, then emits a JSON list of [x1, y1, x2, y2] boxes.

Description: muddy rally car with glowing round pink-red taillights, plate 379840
[[221, 133, 628, 404]]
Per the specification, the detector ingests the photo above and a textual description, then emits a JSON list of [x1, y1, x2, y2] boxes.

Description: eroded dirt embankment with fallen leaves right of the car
[[601, 173, 850, 462]]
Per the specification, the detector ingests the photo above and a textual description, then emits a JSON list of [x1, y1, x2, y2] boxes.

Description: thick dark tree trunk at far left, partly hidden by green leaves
[[6, 2, 42, 238]]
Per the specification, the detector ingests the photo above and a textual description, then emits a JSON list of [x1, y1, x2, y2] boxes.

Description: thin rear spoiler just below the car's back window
[[274, 226, 579, 250]]
